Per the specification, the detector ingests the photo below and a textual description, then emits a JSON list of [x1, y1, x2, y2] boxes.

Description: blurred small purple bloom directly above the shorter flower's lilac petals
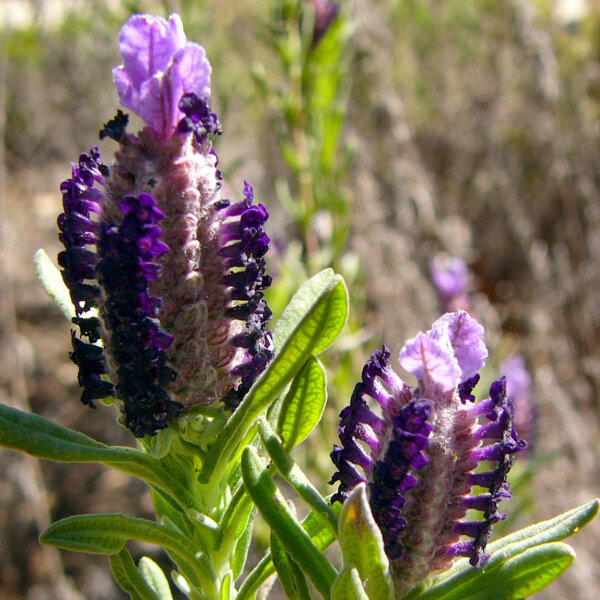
[[429, 254, 473, 312]]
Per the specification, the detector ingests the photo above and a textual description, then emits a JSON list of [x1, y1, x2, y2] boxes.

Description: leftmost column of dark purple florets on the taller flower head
[[57, 148, 114, 408]]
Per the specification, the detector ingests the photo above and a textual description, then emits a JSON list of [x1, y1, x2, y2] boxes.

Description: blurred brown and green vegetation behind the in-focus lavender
[[0, 0, 600, 600]]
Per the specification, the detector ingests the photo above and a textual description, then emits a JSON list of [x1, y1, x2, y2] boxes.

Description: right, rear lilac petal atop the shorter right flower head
[[427, 310, 488, 381]]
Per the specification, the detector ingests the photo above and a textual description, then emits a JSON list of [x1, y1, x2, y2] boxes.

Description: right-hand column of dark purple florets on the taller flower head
[[220, 181, 274, 408]]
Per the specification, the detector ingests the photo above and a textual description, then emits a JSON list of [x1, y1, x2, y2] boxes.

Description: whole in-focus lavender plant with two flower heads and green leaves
[[0, 15, 599, 600]]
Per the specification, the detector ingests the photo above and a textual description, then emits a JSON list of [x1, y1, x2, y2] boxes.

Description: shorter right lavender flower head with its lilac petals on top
[[331, 311, 526, 595]]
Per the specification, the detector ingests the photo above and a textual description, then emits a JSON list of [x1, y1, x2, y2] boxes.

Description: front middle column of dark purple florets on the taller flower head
[[97, 193, 182, 437]]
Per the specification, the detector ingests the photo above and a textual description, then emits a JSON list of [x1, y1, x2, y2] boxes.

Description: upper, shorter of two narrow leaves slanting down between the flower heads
[[258, 418, 338, 532]]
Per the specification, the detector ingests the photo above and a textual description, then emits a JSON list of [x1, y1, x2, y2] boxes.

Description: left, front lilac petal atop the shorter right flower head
[[400, 333, 461, 392]]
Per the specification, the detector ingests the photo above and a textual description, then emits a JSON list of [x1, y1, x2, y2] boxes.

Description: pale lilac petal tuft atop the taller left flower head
[[113, 15, 211, 139]]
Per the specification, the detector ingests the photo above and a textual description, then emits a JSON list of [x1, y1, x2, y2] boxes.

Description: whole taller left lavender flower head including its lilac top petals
[[58, 15, 273, 436]]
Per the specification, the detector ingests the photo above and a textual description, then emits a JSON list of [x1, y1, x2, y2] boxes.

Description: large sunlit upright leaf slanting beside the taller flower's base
[[198, 269, 348, 486]]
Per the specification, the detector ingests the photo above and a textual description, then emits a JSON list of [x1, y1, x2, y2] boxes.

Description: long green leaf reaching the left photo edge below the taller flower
[[0, 404, 198, 508]]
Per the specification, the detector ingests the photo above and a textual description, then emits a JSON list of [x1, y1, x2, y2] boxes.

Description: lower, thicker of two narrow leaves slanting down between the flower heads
[[242, 446, 337, 600]]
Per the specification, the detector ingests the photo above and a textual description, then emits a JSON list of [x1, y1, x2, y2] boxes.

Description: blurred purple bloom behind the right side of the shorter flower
[[500, 354, 538, 453]]
